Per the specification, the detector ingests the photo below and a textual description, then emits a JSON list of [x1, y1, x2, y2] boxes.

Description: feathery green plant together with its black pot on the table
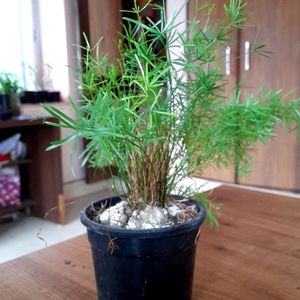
[[44, 0, 300, 300]]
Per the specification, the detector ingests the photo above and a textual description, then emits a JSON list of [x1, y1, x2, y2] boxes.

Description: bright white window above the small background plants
[[0, 0, 73, 95]]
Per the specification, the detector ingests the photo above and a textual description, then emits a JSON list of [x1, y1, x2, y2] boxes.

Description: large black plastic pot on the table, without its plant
[[81, 197, 206, 300]]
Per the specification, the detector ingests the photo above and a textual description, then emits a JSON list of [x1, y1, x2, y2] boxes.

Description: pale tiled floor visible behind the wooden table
[[0, 179, 219, 263]]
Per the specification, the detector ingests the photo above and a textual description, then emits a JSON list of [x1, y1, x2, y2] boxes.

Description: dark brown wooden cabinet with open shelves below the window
[[0, 119, 63, 223]]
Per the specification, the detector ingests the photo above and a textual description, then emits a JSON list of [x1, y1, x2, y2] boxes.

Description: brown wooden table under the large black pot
[[0, 187, 300, 300]]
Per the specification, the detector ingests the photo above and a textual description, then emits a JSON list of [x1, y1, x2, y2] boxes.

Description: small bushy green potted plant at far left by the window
[[0, 72, 22, 115]]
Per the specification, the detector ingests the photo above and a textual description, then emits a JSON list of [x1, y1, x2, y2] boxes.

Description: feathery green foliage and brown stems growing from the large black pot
[[44, 0, 300, 225]]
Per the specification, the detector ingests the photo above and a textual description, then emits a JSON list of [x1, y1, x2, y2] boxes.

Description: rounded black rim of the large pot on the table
[[80, 195, 206, 238]]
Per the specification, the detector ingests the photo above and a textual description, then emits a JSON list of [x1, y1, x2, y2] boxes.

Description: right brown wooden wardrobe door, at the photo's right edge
[[238, 0, 300, 190]]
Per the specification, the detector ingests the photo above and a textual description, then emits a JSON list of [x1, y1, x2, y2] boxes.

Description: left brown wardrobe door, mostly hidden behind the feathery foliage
[[188, 0, 238, 183]]
